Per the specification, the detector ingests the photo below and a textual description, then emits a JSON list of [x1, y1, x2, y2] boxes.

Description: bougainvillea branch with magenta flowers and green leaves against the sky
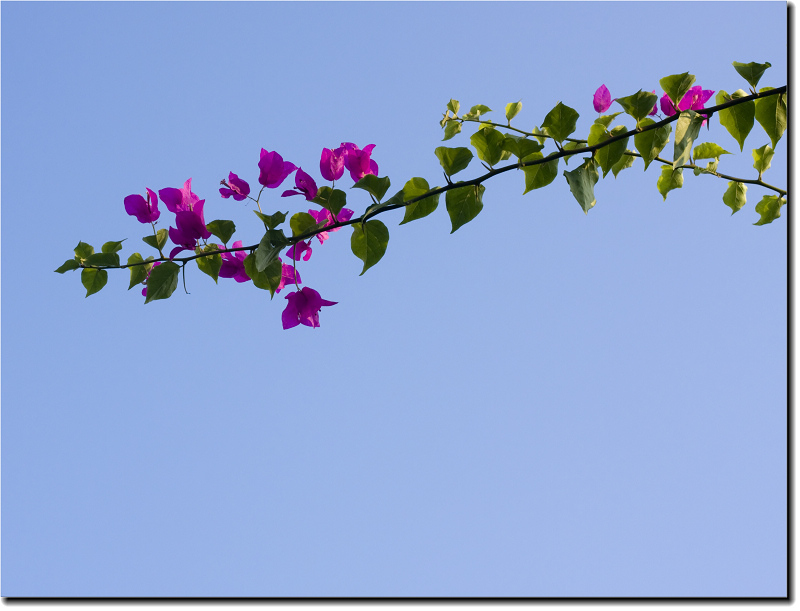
[[55, 62, 787, 329]]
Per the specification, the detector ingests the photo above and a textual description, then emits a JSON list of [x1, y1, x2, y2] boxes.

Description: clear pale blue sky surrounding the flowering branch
[[0, 2, 788, 596]]
